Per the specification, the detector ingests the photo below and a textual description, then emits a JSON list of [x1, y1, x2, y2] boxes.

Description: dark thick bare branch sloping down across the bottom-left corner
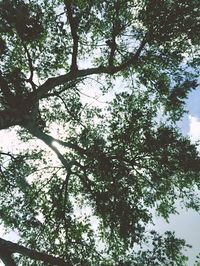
[[0, 238, 72, 266]]
